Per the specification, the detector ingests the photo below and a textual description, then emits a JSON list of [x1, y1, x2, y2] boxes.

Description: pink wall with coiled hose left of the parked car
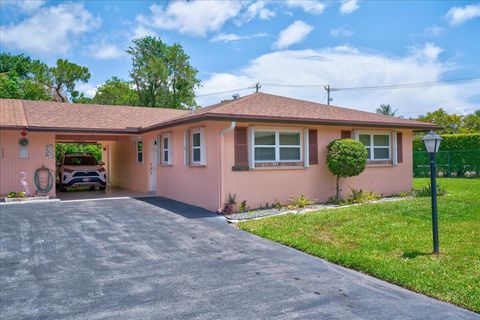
[[0, 130, 55, 196]]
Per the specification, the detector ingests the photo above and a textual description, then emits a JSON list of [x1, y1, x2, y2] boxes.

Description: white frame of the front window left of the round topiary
[[251, 128, 304, 166]]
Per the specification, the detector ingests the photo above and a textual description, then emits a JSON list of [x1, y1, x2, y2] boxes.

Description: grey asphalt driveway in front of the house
[[0, 198, 480, 319]]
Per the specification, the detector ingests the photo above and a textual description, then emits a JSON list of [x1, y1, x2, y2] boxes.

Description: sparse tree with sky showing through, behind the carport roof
[[33, 59, 90, 102]]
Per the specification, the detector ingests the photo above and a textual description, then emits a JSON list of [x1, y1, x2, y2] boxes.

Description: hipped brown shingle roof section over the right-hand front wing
[[146, 92, 439, 130]]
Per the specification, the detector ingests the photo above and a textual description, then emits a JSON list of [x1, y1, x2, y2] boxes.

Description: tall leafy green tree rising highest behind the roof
[[126, 37, 200, 109]]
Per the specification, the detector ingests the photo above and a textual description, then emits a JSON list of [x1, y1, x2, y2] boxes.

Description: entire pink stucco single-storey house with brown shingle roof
[[0, 93, 436, 210]]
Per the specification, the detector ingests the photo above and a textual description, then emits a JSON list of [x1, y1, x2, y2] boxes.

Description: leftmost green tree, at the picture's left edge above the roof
[[0, 53, 50, 100]]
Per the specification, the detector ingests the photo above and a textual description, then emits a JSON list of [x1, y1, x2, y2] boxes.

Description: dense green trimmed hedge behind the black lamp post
[[413, 133, 480, 177]]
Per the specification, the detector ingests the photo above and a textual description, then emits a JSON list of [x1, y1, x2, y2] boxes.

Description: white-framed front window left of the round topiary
[[253, 130, 302, 162]]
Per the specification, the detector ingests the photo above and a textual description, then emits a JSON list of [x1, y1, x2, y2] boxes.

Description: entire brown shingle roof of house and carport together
[[0, 93, 439, 133]]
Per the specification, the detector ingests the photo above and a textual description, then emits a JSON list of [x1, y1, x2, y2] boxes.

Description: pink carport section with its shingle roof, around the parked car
[[0, 99, 186, 199]]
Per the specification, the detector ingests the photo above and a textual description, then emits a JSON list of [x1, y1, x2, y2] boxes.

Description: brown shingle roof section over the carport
[[0, 99, 187, 132]]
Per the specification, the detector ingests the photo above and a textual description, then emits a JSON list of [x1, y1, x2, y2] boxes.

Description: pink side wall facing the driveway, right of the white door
[[149, 121, 223, 210]]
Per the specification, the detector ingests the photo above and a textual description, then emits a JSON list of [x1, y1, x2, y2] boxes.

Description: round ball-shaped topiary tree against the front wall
[[327, 139, 368, 201]]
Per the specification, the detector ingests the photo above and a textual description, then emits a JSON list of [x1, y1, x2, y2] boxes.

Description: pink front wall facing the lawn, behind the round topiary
[[222, 123, 412, 208]]
